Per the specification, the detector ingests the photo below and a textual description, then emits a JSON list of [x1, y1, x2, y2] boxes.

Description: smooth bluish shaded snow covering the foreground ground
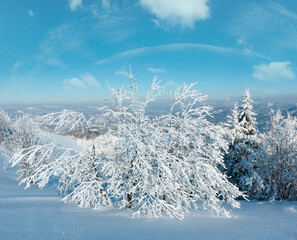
[[0, 153, 297, 240]]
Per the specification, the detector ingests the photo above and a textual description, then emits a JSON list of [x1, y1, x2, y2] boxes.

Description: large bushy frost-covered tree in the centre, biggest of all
[[103, 74, 241, 218]]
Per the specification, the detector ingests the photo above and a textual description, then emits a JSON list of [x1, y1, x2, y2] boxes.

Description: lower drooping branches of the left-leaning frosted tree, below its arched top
[[12, 143, 111, 208]]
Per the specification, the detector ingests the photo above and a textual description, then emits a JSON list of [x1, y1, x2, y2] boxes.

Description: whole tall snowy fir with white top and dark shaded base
[[225, 90, 263, 199]]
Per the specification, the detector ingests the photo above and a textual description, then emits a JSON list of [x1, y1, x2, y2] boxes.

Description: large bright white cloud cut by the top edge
[[140, 0, 209, 28]]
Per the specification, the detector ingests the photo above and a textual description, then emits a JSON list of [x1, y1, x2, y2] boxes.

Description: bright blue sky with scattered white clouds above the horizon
[[0, 0, 297, 104]]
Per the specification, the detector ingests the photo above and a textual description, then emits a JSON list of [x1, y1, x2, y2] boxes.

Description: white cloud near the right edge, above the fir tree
[[253, 61, 295, 82]]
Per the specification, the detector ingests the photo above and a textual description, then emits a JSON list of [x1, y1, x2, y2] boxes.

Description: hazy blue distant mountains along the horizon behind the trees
[[2, 100, 297, 131]]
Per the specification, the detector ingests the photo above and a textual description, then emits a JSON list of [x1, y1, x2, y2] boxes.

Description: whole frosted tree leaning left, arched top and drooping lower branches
[[11, 110, 111, 208]]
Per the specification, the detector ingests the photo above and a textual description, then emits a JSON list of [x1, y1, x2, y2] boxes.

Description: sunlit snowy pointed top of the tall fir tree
[[239, 89, 257, 138]]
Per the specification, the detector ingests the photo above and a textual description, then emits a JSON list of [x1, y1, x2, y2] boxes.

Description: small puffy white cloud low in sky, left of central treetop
[[63, 72, 100, 89]]
